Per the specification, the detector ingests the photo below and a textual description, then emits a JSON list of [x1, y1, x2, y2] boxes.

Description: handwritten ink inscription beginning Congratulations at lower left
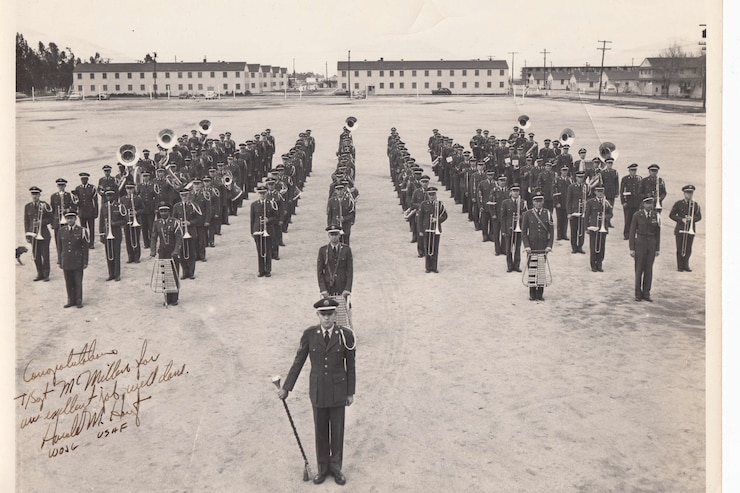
[[15, 340, 188, 458]]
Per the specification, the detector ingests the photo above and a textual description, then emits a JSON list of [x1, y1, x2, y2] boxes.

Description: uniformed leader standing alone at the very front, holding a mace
[[278, 298, 355, 485]]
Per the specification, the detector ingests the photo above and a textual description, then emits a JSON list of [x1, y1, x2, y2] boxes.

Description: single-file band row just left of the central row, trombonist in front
[[250, 129, 316, 277]]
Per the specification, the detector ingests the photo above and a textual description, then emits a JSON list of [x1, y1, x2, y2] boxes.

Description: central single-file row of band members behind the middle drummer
[[326, 117, 360, 246]]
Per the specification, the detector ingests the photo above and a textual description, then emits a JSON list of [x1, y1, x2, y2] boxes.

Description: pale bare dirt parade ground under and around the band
[[15, 97, 706, 493]]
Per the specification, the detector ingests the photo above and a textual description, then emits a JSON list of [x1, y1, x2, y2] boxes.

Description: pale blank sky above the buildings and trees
[[15, 0, 718, 76]]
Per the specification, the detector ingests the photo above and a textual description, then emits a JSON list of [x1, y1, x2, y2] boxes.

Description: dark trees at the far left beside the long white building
[[15, 33, 109, 94]]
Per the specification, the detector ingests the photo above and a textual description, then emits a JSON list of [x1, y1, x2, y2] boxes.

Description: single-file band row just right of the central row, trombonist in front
[[387, 127, 447, 273]]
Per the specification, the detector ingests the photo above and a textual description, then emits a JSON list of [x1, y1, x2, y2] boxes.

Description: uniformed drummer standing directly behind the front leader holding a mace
[[316, 224, 353, 298]]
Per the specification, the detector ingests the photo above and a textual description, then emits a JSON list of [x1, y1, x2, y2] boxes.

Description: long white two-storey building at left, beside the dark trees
[[72, 62, 288, 97]]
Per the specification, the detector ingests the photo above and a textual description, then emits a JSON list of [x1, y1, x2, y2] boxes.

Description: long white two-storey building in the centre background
[[337, 58, 509, 95]]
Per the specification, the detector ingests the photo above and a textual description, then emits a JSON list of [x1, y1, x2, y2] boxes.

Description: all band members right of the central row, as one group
[[387, 115, 701, 301]]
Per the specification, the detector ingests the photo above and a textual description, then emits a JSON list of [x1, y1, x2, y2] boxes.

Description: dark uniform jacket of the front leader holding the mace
[[283, 324, 355, 407]]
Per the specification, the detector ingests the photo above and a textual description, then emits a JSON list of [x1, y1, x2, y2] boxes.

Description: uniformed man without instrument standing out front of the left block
[[58, 211, 90, 308]]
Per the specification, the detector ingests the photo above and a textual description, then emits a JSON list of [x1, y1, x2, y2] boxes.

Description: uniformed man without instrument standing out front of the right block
[[629, 197, 660, 301]]
